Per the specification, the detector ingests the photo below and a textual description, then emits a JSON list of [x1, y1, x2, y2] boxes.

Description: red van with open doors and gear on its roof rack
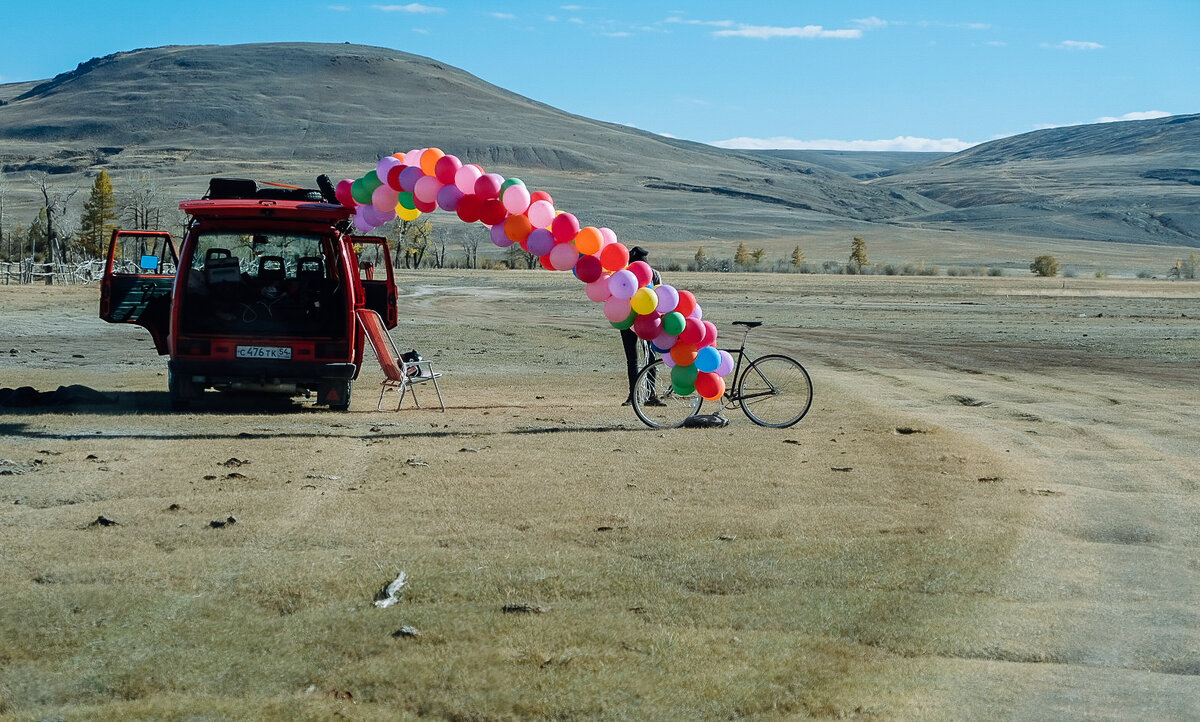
[[100, 176, 396, 410]]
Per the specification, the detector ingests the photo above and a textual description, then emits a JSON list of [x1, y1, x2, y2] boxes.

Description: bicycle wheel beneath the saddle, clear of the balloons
[[738, 354, 812, 428]]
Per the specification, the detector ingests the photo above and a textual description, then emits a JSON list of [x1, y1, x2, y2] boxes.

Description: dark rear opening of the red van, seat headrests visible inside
[[179, 231, 347, 337]]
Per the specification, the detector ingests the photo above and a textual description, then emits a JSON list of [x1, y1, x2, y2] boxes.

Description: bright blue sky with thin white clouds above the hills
[[0, 0, 1200, 150]]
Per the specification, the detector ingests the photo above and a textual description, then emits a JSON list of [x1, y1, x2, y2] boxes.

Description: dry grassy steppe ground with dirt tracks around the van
[[0, 272, 1200, 721]]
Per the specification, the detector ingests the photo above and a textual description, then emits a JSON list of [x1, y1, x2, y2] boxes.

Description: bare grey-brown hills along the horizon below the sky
[[0, 43, 1200, 246]]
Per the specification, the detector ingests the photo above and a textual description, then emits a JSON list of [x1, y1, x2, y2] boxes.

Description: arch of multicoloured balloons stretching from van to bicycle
[[336, 148, 733, 401]]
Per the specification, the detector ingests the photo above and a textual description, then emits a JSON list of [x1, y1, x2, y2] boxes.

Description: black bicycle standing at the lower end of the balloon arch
[[634, 321, 812, 428]]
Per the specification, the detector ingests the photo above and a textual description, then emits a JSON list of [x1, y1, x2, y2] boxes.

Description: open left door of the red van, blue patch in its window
[[100, 230, 179, 354]]
